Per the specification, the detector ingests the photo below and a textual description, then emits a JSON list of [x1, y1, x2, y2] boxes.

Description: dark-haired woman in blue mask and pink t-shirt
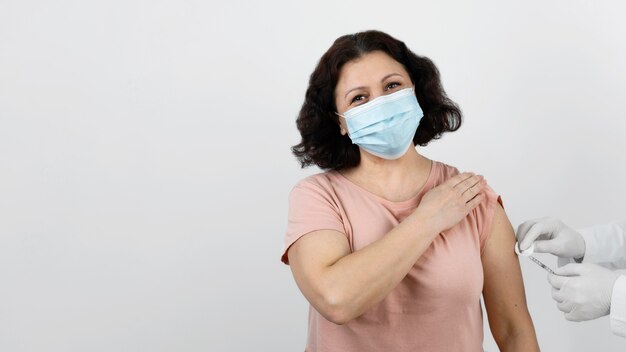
[[282, 31, 539, 352]]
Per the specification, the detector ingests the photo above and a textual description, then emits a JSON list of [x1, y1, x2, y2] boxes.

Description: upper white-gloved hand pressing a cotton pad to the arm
[[516, 218, 585, 259]]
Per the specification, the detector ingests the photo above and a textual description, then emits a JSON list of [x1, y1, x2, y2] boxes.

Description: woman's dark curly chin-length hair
[[291, 30, 461, 170]]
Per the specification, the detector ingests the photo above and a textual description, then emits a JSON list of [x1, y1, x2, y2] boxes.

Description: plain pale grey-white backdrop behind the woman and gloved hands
[[0, 0, 626, 352]]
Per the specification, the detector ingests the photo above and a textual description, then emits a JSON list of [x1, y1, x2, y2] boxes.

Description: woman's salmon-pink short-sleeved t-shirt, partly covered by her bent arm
[[282, 161, 501, 352]]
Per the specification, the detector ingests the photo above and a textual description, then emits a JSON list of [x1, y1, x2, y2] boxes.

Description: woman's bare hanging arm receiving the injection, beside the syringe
[[482, 205, 538, 348]]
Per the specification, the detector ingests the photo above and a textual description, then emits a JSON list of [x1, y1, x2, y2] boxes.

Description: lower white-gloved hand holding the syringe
[[548, 264, 619, 321]]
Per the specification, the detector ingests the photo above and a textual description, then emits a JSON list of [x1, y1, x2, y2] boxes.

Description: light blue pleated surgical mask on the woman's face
[[340, 88, 424, 160]]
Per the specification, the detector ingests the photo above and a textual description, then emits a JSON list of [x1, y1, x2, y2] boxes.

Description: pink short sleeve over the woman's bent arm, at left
[[281, 182, 345, 264]]
